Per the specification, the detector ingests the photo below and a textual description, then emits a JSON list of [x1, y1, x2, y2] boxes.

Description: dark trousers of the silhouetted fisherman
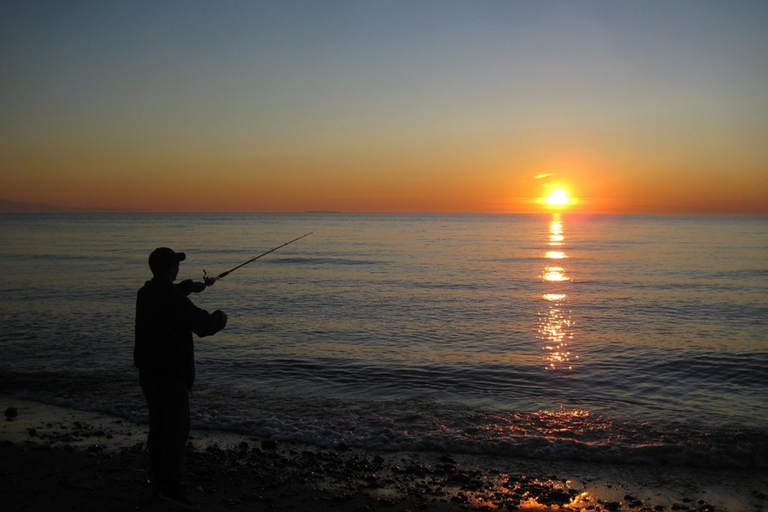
[[139, 372, 189, 489]]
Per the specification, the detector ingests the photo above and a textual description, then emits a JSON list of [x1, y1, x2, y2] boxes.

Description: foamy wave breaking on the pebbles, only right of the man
[[186, 407, 768, 468]]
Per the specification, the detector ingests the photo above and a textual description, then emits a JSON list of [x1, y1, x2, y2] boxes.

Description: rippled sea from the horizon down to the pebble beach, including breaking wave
[[0, 213, 768, 468]]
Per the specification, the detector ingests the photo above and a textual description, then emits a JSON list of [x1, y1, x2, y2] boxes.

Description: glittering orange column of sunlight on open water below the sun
[[537, 213, 579, 370]]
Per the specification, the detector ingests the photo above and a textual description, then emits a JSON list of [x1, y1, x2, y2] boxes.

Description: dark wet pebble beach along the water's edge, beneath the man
[[0, 395, 768, 512]]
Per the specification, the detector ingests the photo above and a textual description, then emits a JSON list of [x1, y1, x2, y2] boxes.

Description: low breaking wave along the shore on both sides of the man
[[7, 374, 768, 468]]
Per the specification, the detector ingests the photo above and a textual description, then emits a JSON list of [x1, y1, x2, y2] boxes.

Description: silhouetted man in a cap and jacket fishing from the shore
[[133, 247, 227, 510]]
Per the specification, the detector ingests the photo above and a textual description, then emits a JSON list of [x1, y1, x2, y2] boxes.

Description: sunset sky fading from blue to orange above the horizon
[[0, 0, 768, 214]]
